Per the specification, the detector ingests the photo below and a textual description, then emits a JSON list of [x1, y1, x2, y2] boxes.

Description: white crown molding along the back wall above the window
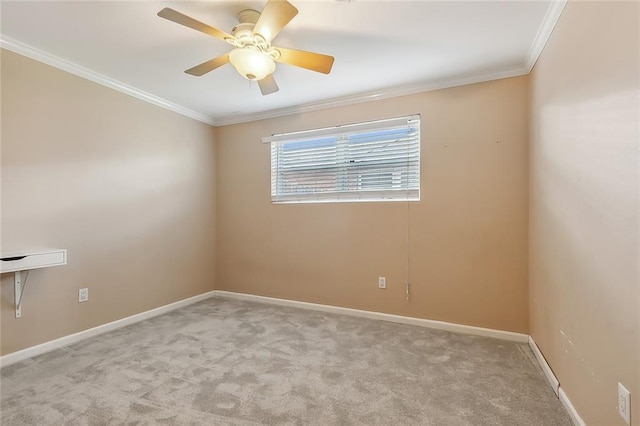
[[216, 65, 529, 126]]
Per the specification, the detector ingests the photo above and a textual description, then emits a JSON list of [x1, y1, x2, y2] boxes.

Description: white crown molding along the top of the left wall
[[0, 35, 215, 126]]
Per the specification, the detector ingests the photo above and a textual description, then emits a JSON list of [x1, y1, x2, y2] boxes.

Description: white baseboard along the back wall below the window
[[213, 290, 529, 343]]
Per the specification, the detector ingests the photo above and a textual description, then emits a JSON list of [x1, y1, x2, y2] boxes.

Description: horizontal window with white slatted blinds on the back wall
[[264, 115, 420, 203]]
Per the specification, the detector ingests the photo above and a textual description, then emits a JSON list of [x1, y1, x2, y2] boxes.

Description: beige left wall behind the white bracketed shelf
[[0, 51, 215, 354]]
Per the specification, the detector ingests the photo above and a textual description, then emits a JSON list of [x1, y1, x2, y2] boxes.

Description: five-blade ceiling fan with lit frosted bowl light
[[158, 0, 334, 95]]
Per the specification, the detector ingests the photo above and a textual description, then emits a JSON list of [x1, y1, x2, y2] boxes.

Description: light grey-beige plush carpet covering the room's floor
[[0, 299, 571, 426]]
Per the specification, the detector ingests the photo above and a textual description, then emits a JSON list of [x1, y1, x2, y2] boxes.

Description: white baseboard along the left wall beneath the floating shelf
[[0, 291, 215, 368]]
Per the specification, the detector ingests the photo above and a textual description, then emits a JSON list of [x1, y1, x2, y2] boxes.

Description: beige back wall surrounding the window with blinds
[[216, 77, 529, 333]]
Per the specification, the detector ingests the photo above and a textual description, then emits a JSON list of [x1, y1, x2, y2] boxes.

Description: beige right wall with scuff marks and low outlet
[[530, 2, 640, 426]]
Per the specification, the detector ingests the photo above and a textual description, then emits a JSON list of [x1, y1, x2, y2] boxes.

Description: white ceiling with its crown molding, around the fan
[[0, 0, 564, 124]]
